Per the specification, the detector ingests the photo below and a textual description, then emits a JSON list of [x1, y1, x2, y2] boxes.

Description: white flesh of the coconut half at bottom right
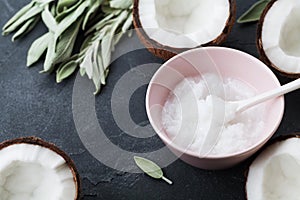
[[246, 138, 300, 200]]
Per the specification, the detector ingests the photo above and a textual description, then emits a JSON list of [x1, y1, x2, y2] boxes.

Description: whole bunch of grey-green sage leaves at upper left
[[2, 0, 132, 94]]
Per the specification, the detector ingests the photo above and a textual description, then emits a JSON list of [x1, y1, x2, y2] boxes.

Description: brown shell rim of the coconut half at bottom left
[[0, 137, 81, 200]]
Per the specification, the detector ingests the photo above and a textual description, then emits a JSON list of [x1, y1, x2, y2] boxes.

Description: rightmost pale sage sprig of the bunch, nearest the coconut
[[80, 2, 132, 94]]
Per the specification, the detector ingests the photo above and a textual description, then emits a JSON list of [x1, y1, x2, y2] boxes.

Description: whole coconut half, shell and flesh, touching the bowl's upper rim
[[133, 0, 236, 59]]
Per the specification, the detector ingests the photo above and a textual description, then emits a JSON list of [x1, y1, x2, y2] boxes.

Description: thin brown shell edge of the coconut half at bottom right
[[245, 133, 300, 199]]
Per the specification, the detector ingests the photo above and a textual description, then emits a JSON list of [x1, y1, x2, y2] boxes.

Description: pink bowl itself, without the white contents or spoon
[[146, 47, 284, 169]]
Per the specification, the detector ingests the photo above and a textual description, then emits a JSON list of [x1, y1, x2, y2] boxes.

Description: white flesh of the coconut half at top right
[[261, 0, 300, 73]]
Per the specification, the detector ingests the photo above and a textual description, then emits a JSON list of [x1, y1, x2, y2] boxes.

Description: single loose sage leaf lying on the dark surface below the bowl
[[134, 156, 173, 184]]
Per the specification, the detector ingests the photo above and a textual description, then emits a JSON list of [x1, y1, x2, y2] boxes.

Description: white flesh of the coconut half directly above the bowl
[[138, 0, 230, 48]]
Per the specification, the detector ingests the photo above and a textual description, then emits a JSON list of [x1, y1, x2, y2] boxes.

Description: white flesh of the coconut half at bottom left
[[0, 144, 76, 200]]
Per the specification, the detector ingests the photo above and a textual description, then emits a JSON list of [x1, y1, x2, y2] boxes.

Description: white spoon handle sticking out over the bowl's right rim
[[237, 78, 300, 112]]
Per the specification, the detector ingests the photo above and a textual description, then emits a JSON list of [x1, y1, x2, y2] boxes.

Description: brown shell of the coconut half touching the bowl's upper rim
[[133, 0, 236, 60]]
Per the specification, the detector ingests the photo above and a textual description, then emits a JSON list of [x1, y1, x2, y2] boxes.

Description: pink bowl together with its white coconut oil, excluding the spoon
[[146, 47, 284, 169]]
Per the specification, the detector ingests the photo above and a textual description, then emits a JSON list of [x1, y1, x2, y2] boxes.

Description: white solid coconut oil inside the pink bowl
[[162, 74, 265, 155]]
